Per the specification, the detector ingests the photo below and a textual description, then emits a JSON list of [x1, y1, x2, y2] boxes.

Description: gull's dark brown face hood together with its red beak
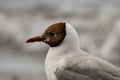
[[26, 22, 66, 47]]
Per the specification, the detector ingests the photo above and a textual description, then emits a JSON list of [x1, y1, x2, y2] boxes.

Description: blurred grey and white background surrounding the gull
[[0, 0, 120, 80]]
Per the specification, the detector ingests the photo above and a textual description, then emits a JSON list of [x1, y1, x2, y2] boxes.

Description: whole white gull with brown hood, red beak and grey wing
[[26, 22, 120, 80]]
